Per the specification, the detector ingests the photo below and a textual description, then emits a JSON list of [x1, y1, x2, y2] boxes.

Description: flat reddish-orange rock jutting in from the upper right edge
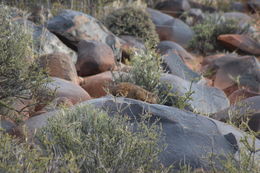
[[218, 34, 260, 56]]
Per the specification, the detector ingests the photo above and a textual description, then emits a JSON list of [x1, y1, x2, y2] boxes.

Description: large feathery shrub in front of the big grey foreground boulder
[[37, 105, 165, 172]]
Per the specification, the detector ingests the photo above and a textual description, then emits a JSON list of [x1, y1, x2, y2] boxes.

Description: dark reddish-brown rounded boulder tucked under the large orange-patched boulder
[[76, 40, 115, 76]]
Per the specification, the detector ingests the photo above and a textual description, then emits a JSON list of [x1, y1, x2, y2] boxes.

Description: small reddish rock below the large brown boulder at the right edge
[[228, 89, 260, 104]]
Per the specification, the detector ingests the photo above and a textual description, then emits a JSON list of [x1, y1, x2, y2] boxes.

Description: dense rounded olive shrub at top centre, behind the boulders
[[104, 7, 159, 47]]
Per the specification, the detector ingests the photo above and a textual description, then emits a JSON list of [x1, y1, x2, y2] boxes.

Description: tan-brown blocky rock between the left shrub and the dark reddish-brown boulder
[[39, 53, 78, 84]]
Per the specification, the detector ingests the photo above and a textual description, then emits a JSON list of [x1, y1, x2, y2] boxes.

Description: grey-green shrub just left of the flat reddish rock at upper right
[[189, 15, 249, 54]]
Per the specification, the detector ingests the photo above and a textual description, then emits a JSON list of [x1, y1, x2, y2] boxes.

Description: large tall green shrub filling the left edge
[[0, 8, 53, 119]]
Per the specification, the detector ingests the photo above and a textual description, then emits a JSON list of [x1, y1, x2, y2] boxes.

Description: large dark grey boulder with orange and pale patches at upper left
[[47, 10, 121, 59]]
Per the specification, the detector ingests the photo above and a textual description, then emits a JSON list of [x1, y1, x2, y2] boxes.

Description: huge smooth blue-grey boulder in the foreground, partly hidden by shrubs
[[21, 97, 260, 168]]
